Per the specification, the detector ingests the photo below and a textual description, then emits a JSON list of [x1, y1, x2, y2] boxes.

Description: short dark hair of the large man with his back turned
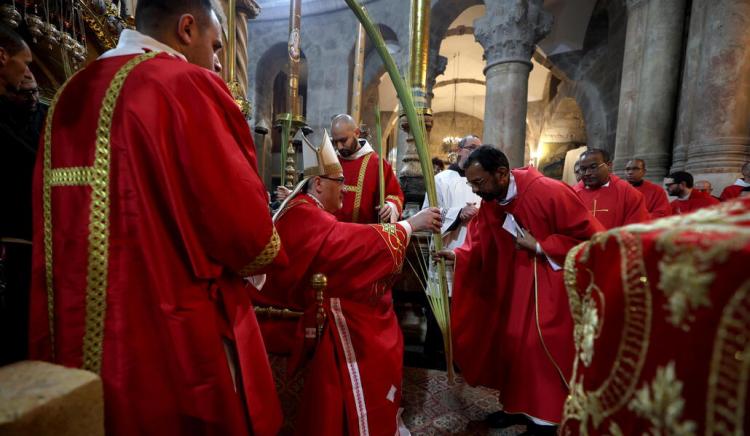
[[135, 0, 219, 31]]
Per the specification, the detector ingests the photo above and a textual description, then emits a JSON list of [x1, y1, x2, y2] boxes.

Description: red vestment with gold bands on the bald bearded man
[[336, 146, 404, 224]]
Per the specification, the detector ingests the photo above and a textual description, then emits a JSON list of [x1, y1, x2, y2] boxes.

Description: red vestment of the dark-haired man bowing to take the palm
[[451, 168, 604, 422]]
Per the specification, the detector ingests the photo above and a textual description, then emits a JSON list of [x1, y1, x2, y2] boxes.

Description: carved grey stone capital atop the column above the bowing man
[[474, 0, 552, 74]]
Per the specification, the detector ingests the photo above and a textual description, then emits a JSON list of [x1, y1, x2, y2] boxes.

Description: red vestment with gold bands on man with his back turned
[[30, 53, 286, 435]]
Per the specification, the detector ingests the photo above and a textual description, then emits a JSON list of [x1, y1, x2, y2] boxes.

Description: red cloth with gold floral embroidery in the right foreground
[[561, 198, 750, 435]]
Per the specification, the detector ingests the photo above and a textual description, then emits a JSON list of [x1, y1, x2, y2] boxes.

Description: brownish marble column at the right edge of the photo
[[678, 0, 750, 190]]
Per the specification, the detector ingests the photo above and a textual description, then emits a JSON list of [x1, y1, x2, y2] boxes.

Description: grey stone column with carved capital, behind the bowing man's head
[[474, 0, 552, 168]]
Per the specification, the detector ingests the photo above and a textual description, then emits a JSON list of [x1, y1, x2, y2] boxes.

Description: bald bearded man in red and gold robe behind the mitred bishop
[[331, 114, 404, 224]]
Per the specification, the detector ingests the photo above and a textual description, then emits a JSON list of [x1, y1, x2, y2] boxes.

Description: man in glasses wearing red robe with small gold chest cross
[[573, 148, 650, 229]]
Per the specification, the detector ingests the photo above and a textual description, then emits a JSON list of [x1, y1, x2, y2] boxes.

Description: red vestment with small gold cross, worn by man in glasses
[[573, 174, 650, 229]]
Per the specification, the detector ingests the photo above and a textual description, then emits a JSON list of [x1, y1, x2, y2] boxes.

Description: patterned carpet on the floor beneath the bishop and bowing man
[[269, 355, 525, 436]]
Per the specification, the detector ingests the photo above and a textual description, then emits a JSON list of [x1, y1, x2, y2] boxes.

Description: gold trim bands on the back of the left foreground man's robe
[[43, 52, 158, 373]]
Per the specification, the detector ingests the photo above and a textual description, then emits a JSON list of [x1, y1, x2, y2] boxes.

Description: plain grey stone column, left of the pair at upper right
[[614, 0, 685, 183]]
